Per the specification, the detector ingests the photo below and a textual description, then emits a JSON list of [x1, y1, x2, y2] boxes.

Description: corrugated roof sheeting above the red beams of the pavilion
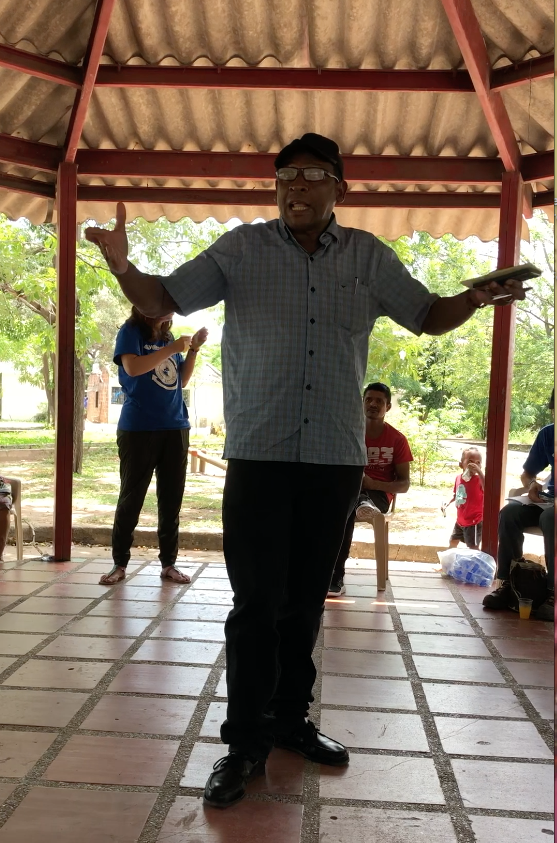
[[0, 0, 554, 239]]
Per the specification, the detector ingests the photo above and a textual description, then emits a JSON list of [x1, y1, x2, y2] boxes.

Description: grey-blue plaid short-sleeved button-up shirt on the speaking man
[[161, 217, 437, 466]]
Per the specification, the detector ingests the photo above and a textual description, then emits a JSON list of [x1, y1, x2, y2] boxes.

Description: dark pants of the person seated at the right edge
[[497, 501, 555, 586]]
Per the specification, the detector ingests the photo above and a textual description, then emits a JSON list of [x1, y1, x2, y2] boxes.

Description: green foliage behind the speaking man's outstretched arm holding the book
[[376, 211, 554, 438]]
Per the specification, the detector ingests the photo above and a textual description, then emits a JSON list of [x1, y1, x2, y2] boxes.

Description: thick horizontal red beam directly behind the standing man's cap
[[76, 149, 502, 184]]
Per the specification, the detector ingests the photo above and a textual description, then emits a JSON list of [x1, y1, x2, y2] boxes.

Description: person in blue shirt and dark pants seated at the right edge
[[483, 391, 555, 621]]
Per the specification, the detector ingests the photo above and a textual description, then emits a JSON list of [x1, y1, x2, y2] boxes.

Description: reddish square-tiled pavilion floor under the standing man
[[0, 549, 554, 843]]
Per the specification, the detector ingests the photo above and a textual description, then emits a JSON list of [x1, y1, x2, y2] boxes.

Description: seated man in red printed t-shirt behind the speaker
[[327, 383, 414, 597]]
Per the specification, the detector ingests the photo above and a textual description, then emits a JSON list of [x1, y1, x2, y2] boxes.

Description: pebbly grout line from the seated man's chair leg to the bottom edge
[[386, 582, 476, 843]]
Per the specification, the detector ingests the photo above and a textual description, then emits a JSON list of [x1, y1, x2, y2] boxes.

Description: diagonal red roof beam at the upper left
[[64, 0, 116, 163]]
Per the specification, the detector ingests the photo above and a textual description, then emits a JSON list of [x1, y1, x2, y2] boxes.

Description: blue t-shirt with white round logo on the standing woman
[[114, 322, 190, 430]]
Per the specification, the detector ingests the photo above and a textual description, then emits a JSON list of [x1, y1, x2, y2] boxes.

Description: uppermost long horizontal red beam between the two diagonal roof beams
[[95, 64, 474, 93]]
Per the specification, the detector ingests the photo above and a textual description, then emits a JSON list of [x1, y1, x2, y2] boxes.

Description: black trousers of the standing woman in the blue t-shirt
[[112, 430, 189, 568]]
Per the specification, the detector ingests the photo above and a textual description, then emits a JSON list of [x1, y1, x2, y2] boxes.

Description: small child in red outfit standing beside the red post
[[441, 447, 485, 550]]
